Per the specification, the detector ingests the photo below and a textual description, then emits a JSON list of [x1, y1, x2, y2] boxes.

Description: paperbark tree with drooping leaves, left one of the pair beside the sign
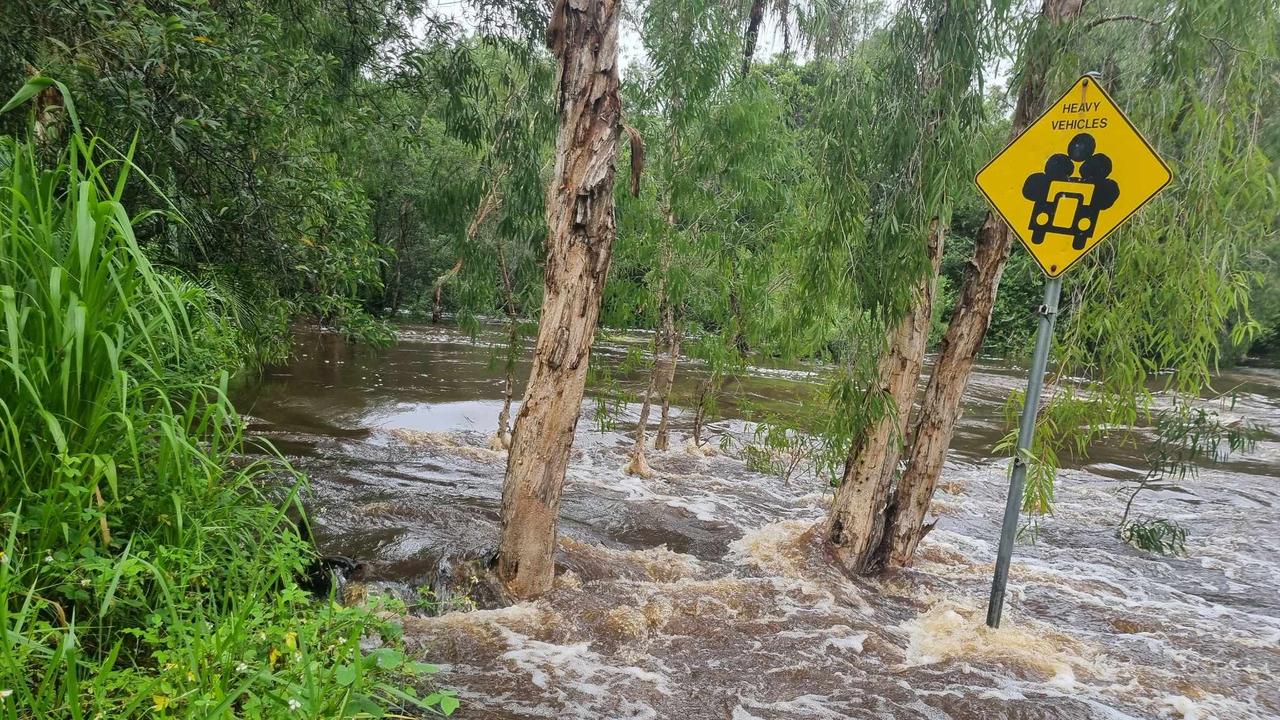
[[824, 1, 992, 573]]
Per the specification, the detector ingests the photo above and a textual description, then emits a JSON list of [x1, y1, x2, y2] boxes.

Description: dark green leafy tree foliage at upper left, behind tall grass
[[0, 0, 471, 348]]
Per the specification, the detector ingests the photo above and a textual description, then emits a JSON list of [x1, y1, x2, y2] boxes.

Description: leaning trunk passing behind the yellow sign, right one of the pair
[[888, 0, 1083, 568]]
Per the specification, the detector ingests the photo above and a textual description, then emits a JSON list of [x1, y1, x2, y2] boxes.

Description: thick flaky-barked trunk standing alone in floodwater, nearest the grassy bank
[[498, 0, 622, 598]]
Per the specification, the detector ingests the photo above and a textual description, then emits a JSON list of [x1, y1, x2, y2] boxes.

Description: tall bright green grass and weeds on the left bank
[[0, 78, 457, 720]]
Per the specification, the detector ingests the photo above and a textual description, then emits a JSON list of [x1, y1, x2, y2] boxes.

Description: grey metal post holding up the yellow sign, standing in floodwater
[[987, 271, 1062, 628]]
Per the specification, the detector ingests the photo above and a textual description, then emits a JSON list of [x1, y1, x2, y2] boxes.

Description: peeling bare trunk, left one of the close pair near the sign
[[826, 219, 942, 573]]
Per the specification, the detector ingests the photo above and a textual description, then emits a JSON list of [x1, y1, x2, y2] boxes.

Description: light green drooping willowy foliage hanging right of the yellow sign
[[1006, 1, 1280, 532]]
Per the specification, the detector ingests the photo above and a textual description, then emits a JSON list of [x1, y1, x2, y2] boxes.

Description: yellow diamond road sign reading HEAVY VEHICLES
[[977, 76, 1172, 278]]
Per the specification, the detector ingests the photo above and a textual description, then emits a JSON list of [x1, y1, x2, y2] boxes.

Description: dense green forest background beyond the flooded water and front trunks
[[0, 0, 1280, 360]]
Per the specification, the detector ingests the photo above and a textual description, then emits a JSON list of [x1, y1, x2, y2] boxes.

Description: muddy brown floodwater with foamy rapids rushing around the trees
[[237, 325, 1280, 720]]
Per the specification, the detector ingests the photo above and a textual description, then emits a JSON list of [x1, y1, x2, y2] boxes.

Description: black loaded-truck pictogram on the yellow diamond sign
[[1023, 132, 1120, 250]]
